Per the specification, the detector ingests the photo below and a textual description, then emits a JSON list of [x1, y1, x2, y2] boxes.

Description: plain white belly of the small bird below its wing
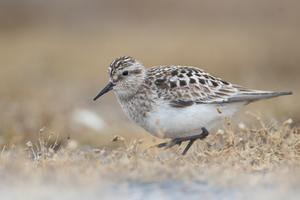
[[144, 103, 243, 138]]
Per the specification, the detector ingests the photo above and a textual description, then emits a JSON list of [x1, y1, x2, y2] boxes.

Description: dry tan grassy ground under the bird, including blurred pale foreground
[[0, 120, 300, 199]]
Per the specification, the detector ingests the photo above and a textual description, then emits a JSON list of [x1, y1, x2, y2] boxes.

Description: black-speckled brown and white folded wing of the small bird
[[147, 66, 291, 107]]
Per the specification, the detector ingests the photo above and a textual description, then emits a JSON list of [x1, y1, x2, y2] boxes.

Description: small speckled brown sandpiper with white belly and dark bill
[[93, 56, 292, 155]]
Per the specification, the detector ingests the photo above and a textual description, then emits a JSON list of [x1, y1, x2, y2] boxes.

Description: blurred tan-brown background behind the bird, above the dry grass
[[0, 0, 300, 146]]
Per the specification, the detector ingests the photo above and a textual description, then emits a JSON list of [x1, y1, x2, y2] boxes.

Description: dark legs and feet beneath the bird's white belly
[[157, 127, 209, 155]]
